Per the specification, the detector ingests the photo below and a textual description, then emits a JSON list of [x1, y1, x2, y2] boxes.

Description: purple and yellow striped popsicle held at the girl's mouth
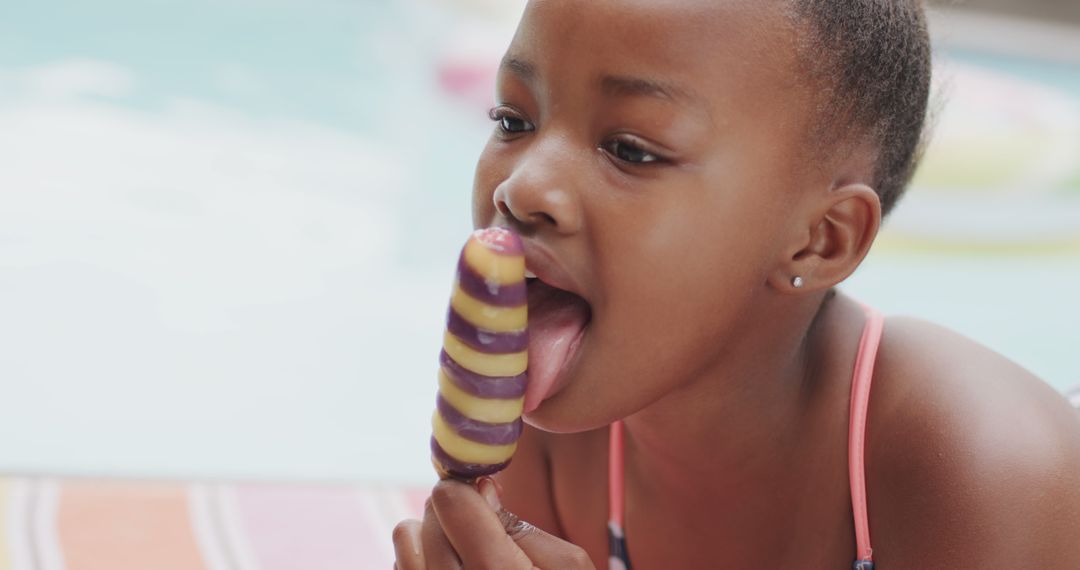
[[431, 228, 528, 480]]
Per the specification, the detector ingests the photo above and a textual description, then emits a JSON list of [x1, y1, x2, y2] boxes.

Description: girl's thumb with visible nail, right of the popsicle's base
[[480, 479, 596, 570]]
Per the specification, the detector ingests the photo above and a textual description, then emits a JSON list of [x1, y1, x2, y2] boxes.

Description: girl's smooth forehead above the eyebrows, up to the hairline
[[504, 0, 797, 112]]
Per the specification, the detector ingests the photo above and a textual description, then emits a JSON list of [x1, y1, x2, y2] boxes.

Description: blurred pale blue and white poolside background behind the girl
[[0, 0, 1080, 490]]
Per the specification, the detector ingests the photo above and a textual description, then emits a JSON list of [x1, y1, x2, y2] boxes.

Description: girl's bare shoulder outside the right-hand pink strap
[[866, 317, 1080, 570]]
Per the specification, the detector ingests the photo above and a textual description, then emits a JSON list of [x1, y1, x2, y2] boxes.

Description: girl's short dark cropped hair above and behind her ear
[[787, 0, 931, 214]]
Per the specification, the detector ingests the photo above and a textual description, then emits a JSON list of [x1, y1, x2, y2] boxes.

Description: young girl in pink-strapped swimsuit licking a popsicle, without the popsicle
[[394, 0, 1080, 570]]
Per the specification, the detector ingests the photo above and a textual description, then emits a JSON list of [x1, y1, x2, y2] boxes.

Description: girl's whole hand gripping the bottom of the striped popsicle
[[393, 477, 595, 570]]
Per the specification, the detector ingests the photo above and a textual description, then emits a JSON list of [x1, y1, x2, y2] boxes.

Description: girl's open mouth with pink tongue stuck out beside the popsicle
[[525, 281, 589, 413]]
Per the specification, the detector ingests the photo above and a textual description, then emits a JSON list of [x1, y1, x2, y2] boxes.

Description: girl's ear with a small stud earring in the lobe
[[769, 184, 881, 293]]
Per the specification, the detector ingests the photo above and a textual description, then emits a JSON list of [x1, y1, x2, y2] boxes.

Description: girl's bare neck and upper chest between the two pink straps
[[624, 296, 862, 568]]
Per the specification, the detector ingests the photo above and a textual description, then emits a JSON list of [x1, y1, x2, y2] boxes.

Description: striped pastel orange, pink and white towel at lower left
[[0, 478, 429, 570]]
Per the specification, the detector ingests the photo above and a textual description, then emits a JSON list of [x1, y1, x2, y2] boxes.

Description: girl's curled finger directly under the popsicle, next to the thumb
[[431, 479, 533, 570]]
